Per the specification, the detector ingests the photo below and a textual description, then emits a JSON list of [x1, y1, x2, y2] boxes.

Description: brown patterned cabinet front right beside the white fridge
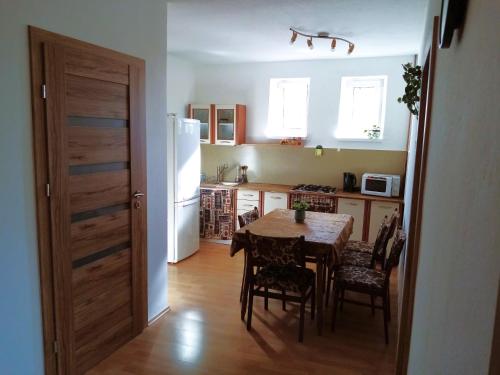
[[200, 188, 235, 240]]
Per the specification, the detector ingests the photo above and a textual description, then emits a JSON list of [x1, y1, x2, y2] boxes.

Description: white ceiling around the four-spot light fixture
[[167, 0, 428, 63]]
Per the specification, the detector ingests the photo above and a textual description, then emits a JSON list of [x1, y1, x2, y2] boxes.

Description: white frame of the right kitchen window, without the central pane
[[334, 75, 388, 142]]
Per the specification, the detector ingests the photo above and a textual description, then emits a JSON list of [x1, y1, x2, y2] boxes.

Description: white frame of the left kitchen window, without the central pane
[[266, 77, 311, 139]]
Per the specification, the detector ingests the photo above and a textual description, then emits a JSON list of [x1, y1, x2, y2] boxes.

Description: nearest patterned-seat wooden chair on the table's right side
[[332, 230, 406, 344]]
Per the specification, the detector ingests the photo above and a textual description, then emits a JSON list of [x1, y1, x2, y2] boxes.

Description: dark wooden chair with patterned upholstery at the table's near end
[[246, 231, 316, 342]]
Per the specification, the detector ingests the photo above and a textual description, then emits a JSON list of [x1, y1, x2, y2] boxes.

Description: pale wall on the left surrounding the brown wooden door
[[0, 0, 167, 375]]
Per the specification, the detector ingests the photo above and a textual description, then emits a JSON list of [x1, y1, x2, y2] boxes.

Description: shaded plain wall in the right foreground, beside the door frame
[[408, 0, 500, 375]]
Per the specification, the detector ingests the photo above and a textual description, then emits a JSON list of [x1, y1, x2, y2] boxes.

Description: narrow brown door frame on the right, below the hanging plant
[[396, 16, 439, 375]]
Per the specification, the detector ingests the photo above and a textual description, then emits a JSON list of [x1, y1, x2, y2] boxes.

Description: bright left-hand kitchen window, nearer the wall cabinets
[[266, 78, 309, 138]]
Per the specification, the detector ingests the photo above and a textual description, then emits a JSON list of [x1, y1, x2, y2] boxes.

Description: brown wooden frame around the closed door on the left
[[28, 26, 148, 375]]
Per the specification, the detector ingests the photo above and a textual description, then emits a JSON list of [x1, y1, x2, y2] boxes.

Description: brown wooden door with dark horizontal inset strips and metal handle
[[29, 27, 147, 374]]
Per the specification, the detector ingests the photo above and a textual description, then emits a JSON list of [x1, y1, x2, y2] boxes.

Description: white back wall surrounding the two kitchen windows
[[190, 56, 414, 150]]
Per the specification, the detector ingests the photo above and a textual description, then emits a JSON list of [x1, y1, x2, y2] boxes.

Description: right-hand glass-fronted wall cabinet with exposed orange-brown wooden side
[[215, 104, 246, 146]]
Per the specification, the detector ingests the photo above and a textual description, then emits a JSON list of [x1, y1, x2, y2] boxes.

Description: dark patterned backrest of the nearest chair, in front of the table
[[246, 230, 305, 266]]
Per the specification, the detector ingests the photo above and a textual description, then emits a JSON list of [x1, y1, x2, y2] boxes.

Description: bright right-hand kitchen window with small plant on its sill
[[335, 76, 387, 139]]
